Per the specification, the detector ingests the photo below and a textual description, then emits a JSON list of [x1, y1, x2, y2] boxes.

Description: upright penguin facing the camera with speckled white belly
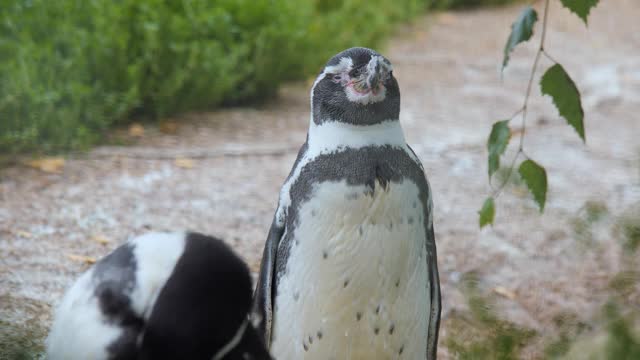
[[252, 48, 440, 360]]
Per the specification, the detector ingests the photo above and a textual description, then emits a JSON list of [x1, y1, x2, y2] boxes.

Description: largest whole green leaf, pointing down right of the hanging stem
[[540, 64, 586, 141]]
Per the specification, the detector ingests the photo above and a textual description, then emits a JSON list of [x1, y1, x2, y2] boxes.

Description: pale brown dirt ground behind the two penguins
[[0, 0, 640, 358]]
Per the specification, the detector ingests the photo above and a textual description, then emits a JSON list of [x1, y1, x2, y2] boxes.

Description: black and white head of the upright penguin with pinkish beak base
[[311, 48, 400, 125]]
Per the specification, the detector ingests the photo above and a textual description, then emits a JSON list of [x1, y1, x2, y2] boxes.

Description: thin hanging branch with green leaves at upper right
[[479, 0, 599, 227]]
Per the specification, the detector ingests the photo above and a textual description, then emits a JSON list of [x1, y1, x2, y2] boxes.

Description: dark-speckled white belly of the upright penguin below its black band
[[271, 180, 430, 360]]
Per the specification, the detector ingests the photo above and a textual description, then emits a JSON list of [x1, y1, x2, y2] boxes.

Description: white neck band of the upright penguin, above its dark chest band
[[307, 119, 406, 154]]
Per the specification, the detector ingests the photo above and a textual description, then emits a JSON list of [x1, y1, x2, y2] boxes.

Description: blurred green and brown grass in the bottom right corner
[[443, 270, 640, 360]]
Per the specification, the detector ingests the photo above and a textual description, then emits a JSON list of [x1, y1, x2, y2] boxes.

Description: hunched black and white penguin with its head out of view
[[46, 233, 271, 360]]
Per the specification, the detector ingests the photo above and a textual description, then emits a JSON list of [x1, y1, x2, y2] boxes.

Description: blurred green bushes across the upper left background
[[0, 0, 516, 155]]
